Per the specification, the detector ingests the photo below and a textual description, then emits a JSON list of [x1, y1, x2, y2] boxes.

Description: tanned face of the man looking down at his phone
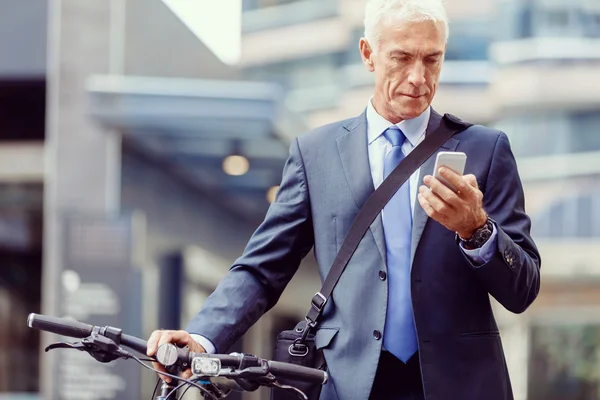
[[360, 20, 446, 124]]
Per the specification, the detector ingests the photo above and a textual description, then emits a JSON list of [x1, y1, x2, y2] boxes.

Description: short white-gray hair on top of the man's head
[[365, 0, 450, 54]]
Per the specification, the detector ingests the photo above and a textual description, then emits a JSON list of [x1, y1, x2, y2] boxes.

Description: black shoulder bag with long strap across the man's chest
[[271, 114, 471, 400]]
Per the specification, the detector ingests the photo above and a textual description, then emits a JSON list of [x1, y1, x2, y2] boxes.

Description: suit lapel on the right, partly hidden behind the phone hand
[[410, 109, 460, 266]]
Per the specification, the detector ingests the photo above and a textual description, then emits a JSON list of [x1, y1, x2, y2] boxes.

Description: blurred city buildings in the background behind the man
[[0, 0, 600, 400]]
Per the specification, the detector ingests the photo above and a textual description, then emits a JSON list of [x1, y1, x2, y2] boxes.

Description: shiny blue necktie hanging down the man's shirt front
[[383, 126, 417, 363]]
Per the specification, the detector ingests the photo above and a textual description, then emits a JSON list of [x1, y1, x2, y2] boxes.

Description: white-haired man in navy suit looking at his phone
[[148, 0, 540, 400]]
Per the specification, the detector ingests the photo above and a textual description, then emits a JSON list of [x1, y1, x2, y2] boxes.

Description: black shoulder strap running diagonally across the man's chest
[[305, 114, 471, 331]]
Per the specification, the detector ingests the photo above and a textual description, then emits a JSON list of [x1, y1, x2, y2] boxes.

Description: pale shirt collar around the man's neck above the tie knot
[[367, 97, 431, 147]]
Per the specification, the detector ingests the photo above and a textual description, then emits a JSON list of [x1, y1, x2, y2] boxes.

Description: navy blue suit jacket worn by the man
[[187, 111, 540, 400]]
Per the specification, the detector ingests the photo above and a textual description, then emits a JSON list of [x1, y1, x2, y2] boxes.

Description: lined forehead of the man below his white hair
[[379, 19, 446, 53]]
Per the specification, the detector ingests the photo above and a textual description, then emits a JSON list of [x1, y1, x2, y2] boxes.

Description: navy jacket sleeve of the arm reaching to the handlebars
[[186, 139, 314, 352]]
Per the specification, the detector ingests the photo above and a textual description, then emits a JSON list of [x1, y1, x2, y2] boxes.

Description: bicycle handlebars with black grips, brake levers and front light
[[27, 313, 328, 400]]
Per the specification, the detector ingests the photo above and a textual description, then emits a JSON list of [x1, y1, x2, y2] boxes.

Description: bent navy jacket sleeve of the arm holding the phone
[[467, 132, 541, 313]]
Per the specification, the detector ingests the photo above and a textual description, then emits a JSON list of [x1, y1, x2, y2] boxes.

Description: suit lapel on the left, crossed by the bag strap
[[337, 111, 386, 262]]
